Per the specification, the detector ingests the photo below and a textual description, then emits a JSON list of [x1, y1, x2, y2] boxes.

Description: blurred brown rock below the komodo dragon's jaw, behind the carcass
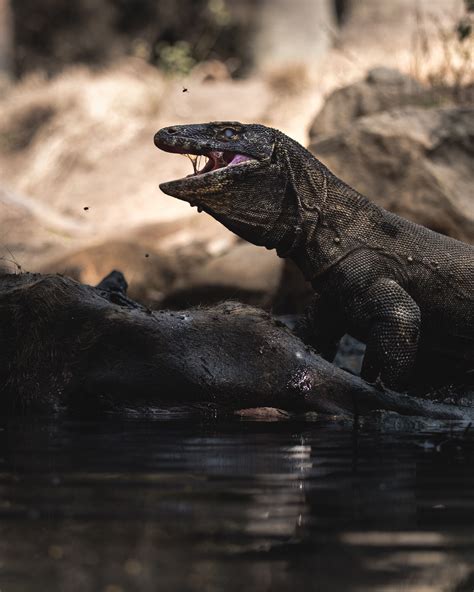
[[40, 216, 282, 308]]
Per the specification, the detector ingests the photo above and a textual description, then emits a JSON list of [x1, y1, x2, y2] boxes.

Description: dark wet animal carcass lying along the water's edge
[[0, 274, 474, 419]]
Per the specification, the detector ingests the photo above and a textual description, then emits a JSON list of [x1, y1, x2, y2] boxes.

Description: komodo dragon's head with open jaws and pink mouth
[[155, 121, 310, 252]]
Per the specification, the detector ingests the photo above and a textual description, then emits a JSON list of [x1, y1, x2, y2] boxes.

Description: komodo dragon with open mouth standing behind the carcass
[[155, 122, 474, 389]]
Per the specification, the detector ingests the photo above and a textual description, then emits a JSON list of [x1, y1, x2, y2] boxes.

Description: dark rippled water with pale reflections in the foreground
[[0, 421, 474, 592]]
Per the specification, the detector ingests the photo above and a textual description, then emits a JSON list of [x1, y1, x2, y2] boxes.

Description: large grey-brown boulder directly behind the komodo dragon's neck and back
[[310, 106, 474, 243]]
